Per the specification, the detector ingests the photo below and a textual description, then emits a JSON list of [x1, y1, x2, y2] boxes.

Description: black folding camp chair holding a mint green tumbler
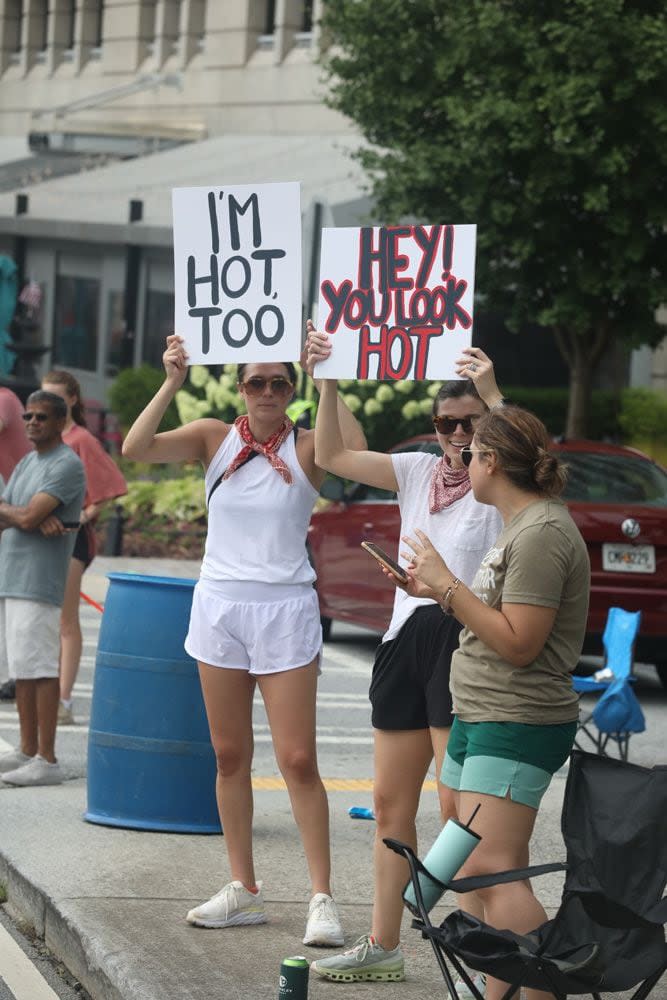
[[384, 750, 667, 1000]]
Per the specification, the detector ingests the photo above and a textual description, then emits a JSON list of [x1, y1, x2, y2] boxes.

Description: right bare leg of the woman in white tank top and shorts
[[257, 660, 331, 896]]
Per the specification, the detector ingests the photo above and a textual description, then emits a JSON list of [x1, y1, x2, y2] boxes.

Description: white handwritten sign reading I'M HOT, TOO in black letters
[[172, 183, 302, 365]]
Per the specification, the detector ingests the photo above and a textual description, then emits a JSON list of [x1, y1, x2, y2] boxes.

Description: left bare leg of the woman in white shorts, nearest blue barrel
[[199, 663, 255, 889]]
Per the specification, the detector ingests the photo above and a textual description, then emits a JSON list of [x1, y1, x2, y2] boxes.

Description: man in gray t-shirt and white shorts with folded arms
[[0, 390, 86, 785]]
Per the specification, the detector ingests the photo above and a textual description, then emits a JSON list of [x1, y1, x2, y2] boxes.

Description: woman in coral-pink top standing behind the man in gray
[[42, 371, 127, 725]]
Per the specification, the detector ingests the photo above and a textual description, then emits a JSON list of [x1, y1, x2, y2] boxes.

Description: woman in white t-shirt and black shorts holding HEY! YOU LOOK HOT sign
[[310, 333, 502, 982]]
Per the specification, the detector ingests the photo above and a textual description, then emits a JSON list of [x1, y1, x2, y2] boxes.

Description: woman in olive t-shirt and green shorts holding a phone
[[403, 406, 590, 1000]]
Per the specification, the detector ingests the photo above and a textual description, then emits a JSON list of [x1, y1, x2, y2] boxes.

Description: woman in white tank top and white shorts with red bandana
[[123, 325, 365, 947]]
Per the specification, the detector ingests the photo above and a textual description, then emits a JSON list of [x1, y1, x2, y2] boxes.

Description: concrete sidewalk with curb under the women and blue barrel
[[0, 558, 667, 1000]]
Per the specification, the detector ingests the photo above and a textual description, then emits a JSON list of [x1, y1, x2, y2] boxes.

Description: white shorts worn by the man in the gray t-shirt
[[0, 597, 60, 681]]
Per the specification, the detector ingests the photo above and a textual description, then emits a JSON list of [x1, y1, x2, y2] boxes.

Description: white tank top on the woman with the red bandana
[[201, 427, 318, 584]]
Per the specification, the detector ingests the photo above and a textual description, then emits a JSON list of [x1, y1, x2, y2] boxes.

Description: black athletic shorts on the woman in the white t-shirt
[[369, 604, 462, 729]]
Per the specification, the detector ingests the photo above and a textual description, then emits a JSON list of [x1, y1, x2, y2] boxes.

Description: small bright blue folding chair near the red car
[[572, 608, 645, 760]]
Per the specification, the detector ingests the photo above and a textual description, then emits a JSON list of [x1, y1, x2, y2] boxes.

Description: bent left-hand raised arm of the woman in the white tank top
[[123, 335, 223, 465]]
